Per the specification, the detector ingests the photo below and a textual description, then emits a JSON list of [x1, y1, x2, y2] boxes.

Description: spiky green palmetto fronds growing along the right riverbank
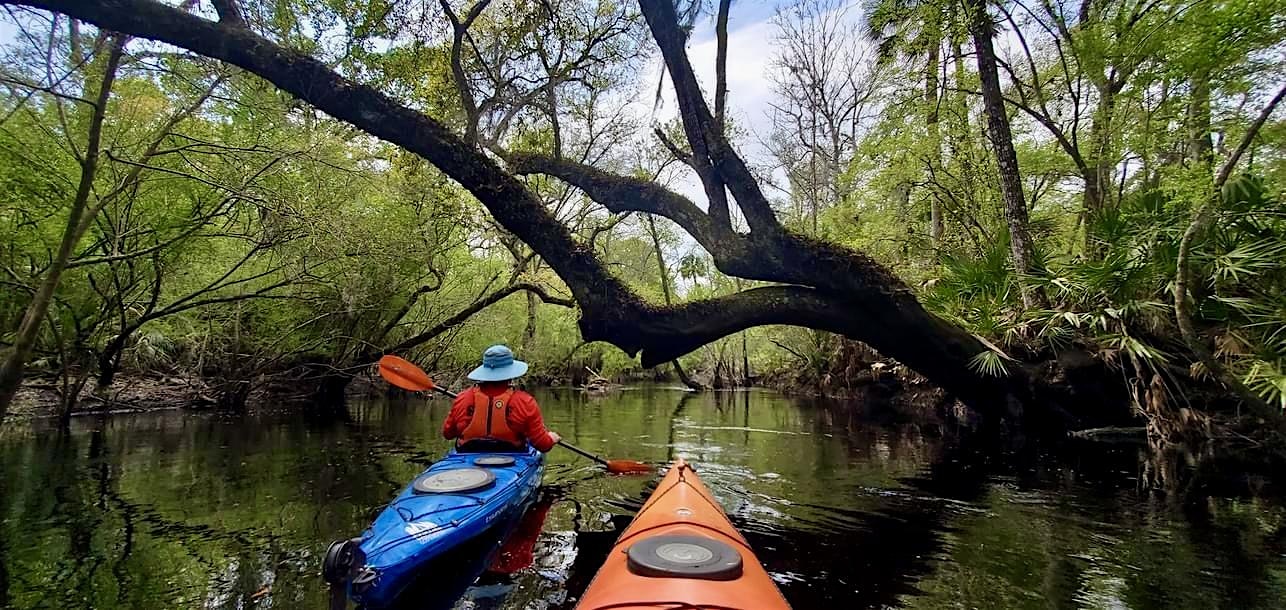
[[925, 175, 1286, 405]]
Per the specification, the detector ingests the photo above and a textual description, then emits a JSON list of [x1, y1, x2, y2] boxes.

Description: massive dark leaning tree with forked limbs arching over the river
[[5, 0, 1049, 424]]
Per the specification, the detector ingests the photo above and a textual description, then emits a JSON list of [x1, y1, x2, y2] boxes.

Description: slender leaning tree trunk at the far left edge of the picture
[[0, 36, 125, 421]]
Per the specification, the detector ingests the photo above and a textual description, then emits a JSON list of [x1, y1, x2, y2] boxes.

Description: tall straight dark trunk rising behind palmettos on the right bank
[[970, 0, 1044, 309]]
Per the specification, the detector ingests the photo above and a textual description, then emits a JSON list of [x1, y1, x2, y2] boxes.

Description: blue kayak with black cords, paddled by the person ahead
[[323, 447, 544, 607]]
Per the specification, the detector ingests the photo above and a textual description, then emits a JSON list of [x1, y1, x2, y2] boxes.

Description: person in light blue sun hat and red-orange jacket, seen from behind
[[442, 345, 559, 452]]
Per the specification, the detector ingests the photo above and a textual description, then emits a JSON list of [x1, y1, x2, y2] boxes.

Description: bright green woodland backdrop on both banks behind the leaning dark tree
[[0, 0, 1286, 414]]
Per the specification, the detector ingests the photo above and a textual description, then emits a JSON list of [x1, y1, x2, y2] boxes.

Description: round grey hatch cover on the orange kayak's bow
[[625, 535, 741, 580]]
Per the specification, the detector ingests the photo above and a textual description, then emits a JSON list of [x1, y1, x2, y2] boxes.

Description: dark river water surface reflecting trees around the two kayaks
[[0, 390, 1286, 610]]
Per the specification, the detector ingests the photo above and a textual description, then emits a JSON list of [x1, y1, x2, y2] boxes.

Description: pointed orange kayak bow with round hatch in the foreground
[[576, 459, 791, 610]]
